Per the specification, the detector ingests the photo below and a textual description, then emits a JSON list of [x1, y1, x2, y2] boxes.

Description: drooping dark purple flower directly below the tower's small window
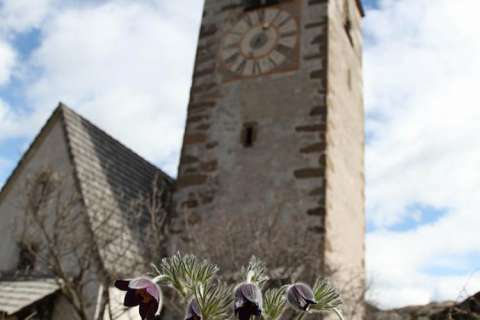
[[234, 283, 263, 320]]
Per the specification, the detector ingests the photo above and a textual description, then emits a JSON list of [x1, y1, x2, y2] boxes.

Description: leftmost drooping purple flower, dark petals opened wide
[[115, 277, 162, 320]]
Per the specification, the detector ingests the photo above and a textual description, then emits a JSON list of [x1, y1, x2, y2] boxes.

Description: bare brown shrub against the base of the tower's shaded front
[[176, 212, 321, 281]]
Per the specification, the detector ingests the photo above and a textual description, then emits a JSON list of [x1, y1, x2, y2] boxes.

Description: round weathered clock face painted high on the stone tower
[[220, 7, 299, 78]]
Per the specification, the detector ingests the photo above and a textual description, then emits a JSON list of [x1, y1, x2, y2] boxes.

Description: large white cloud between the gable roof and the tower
[[2, 0, 202, 174]]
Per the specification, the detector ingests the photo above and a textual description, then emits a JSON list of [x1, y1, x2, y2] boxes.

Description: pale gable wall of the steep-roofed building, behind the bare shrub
[[0, 114, 98, 320]]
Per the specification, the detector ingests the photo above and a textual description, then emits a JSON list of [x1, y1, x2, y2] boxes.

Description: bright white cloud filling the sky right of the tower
[[365, 0, 480, 307]]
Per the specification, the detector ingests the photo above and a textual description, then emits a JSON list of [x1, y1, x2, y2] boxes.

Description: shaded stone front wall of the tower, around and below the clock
[[175, 0, 334, 266]]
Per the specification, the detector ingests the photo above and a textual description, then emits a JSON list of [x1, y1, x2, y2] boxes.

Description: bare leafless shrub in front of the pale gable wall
[[19, 169, 107, 320]]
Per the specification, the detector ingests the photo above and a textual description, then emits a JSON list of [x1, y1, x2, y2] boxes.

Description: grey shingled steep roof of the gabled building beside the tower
[[0, 103, 174, 274]]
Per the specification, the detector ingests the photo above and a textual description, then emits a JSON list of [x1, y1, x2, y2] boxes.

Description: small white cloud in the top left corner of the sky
[[0, 0, 53, 33]]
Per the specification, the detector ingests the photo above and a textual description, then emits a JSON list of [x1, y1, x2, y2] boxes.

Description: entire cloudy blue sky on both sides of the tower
[[0, 0, 480, 307]]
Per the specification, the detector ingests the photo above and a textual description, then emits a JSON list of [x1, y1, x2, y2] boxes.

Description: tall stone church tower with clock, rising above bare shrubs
[[175, 0, 365, 316]]
